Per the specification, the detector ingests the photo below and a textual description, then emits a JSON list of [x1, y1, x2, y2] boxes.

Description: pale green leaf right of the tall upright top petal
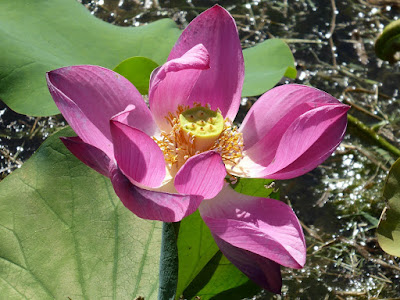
[[242, 39, 297, 97]]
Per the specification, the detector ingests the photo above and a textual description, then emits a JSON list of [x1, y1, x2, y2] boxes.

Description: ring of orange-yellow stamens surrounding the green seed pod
[[154, 103, 243, 174]]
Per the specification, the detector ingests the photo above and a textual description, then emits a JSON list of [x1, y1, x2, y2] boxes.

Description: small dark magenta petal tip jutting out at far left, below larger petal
[[60, 136, 113, 177]]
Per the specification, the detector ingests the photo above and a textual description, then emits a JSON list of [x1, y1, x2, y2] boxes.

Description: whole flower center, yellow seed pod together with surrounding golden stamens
[[153, 103, 243, 176]]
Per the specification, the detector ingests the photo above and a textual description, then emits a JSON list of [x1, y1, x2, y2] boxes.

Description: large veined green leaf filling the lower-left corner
[[0, 129, 162, 300]]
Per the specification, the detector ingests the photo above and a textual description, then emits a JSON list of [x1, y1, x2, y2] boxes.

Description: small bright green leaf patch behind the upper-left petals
[[114, 56, 158, 95]]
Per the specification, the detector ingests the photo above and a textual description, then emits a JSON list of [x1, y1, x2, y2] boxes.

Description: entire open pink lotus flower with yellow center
[[47, 6, 348, 293]]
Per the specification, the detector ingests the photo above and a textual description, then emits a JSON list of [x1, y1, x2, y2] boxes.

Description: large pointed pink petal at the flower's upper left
[[46, 65, 157, 156]]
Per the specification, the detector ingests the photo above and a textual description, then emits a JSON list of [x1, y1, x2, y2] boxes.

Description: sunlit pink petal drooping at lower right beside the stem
[[199, 186, 306, 268]]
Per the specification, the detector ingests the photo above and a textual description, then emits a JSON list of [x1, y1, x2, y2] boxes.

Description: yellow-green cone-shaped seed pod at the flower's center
[[179, 106, 224, 152]]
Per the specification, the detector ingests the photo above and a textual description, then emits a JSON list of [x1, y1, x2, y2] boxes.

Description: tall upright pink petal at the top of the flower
[[168, 5, 244, 120]]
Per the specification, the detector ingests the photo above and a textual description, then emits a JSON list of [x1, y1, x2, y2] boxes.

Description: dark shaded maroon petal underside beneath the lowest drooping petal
[[214, 236, 282, 294]]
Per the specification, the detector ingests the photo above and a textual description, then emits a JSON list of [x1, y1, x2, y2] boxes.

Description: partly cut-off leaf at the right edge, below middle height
[[377, 158, 400, 256]]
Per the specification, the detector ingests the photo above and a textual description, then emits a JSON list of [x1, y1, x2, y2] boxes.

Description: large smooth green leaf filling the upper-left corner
[[0, 0, 180, 116]]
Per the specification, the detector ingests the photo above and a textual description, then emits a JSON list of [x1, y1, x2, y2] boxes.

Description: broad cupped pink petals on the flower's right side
[[234, 85, 349, 179]]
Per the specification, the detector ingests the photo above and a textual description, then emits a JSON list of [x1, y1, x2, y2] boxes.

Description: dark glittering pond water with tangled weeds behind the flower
[[0, 0, 400, 299]]
